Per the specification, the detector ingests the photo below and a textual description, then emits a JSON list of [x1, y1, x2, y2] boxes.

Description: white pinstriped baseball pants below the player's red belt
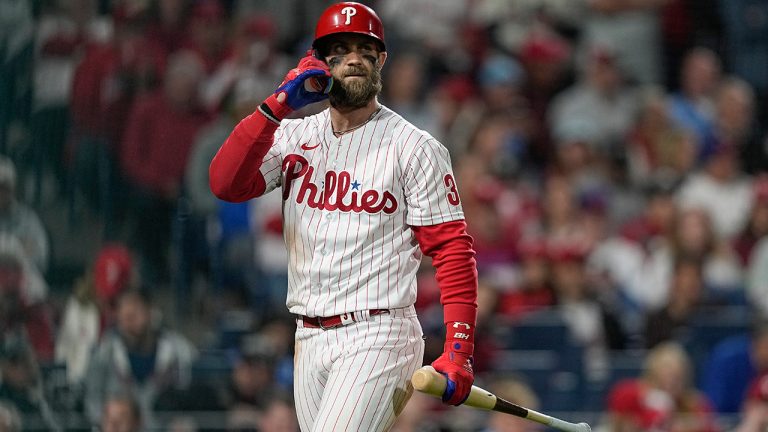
[[293, 307, 424, 432]]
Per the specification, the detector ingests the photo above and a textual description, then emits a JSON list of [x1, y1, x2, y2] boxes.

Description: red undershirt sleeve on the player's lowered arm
[[411, 220, 477, 326]]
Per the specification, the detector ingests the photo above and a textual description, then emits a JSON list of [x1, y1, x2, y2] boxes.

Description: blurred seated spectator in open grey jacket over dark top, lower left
[[85, 290, 196, 427]]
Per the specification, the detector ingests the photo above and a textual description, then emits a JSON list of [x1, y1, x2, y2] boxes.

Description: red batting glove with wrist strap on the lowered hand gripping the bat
[[432, 322, 475, 405]]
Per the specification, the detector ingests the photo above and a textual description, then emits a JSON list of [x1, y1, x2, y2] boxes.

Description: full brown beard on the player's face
[[328, 61, 381, 109]]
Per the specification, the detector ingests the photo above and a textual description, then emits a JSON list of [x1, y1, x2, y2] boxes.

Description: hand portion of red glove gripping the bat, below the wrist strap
[[432, 343, 475, 405]]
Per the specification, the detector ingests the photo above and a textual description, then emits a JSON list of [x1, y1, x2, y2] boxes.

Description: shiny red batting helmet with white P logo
[[312, 2, 386, 51]]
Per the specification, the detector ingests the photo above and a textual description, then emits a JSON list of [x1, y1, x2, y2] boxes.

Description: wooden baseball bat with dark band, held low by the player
[[411, 366, 592, 432]]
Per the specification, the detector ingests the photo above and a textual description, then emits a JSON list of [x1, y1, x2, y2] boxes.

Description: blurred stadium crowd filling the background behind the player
[[0, 0, 768, 432]]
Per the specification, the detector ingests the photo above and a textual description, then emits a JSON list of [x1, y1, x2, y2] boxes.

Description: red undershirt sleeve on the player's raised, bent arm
[[208, 111, 278, 202]]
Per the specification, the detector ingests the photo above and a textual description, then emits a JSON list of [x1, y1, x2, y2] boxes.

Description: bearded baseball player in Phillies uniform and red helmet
[[210, 2, 477, 431]]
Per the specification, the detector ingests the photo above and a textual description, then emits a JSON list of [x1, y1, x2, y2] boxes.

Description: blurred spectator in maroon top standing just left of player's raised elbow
[[121, 51, 210, 281]]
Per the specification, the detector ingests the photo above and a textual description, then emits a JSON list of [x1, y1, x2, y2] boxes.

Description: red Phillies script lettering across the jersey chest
[[283, 154, 397, 214]]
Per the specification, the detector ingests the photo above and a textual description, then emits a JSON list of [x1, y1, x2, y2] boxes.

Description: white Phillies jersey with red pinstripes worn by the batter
[[261, 106, 464, 316]]
